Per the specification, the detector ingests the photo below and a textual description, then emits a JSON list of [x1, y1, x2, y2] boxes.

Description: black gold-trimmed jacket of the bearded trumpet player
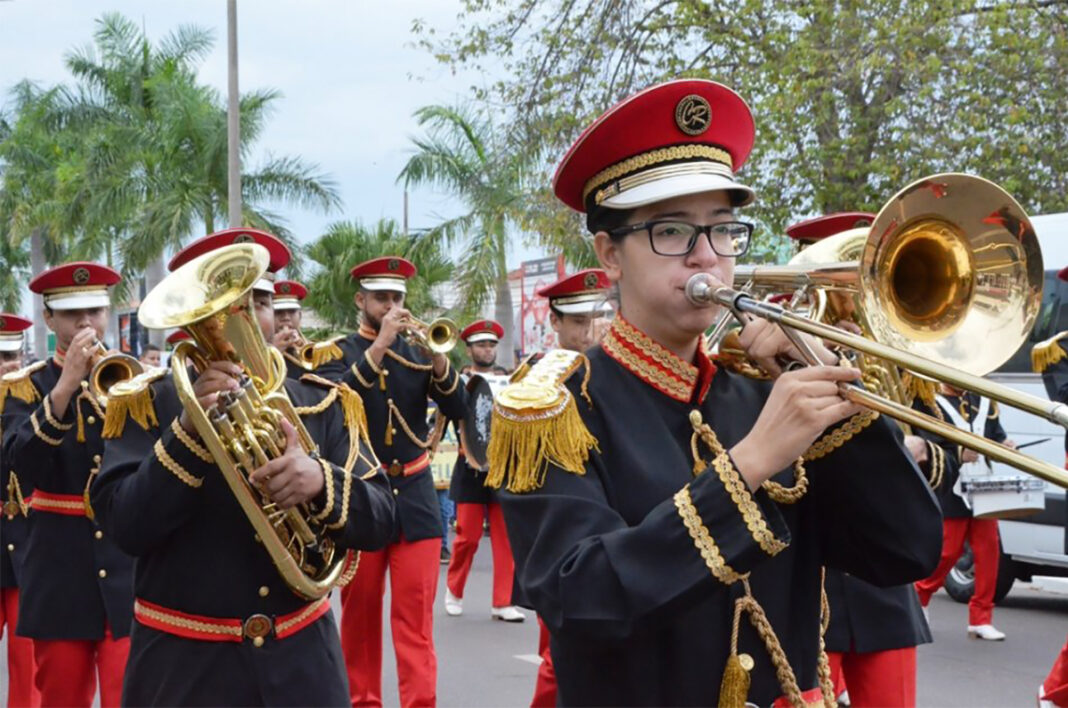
[[333, 333, 467, 541]]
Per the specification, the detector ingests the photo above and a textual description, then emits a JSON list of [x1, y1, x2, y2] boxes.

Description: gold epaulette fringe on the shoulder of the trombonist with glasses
[[485, 392, 597, 492]]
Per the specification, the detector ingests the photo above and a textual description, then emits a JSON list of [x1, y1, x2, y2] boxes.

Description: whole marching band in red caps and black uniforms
[[0, 74, 1068, 707]]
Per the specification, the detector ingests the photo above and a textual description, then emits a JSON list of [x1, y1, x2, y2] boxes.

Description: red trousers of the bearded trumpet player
[[341, 538, 441, 708]]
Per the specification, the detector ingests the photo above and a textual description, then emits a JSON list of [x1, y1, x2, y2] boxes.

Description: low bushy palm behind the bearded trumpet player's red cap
[[304, 219, 453, 332]]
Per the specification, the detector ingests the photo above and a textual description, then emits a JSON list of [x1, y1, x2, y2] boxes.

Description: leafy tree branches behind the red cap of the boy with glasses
[[413, 0, 1068, 257]]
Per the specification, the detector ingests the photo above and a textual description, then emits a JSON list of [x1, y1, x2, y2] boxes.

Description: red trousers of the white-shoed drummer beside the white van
[[914, 519, 1001, 627]]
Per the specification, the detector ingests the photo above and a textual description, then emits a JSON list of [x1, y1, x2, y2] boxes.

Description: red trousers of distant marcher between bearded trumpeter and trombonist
[[445, 504, 516, 608]]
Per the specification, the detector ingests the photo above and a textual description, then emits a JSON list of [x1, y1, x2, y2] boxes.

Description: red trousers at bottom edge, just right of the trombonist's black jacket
[[827, 646, 916, 708]]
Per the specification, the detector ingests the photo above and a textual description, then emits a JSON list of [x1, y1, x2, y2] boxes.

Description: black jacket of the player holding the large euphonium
[[93, 375, 394, 705]]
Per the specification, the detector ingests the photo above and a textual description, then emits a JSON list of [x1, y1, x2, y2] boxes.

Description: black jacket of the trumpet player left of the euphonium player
[[3, 359, 134, 640]]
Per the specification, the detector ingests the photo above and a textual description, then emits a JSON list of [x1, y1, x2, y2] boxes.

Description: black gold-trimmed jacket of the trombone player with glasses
[[501, 337, 942, 706]]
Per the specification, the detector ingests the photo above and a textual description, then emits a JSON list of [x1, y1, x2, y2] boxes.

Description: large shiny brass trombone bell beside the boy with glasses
[[858, 173, 1042, 376]]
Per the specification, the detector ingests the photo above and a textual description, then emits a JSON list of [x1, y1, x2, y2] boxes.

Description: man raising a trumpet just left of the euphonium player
[[2, 263, 134, 708]]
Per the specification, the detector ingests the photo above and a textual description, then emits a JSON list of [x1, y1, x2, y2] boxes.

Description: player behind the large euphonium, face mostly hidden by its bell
[[92, 229, 393, 706]]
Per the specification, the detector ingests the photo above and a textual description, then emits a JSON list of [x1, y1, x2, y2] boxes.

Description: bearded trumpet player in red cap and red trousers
[[339, 256, 467, 706]]
